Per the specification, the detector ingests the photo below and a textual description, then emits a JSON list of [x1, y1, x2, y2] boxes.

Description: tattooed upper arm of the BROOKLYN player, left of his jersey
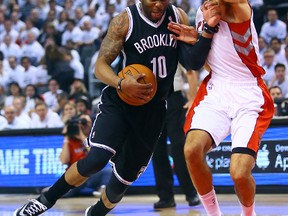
[[98, 12, 129, 65]]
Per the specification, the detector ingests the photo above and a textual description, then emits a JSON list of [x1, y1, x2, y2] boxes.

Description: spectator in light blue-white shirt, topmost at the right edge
[[260, 9, 287, 44]]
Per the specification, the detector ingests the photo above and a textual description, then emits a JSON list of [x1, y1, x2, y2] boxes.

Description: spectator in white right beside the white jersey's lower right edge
[[262, 48, 276, 86]]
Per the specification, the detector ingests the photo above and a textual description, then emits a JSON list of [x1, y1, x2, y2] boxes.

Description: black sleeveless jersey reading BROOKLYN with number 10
[[122, 4, 178, 100]]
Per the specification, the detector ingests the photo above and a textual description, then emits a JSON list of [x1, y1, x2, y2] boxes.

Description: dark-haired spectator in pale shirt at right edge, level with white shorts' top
[[270, 63, 288, 98]]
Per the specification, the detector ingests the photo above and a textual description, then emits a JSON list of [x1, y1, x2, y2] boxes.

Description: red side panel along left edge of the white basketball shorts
[[184, 72, 212, 134]]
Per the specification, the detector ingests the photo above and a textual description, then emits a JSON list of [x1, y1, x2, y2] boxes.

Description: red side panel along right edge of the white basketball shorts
[[248, 78, 274, 153]]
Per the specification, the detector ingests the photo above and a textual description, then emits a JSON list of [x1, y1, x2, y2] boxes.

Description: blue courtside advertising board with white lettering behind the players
[[0, 127, 288, 188]]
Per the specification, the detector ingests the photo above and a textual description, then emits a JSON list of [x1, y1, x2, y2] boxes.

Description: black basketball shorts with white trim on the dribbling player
[[89, 87, 166, 184]]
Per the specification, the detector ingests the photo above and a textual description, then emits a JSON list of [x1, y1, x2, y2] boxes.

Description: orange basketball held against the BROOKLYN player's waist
[[117, 64, 157, 106]]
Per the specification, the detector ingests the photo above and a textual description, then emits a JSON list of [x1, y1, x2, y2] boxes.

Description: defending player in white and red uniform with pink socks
[[169, 0, 273, 216]]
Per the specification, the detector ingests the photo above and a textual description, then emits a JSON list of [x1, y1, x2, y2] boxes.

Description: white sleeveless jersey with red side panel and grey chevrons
[[196, 8, 265, 81]]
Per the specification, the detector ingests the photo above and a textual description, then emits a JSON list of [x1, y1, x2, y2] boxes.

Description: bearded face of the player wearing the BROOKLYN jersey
[[141, 0, 169, 22]]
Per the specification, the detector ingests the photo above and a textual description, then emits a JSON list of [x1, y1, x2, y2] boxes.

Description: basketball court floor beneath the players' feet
[[0, 194, 288, 216]]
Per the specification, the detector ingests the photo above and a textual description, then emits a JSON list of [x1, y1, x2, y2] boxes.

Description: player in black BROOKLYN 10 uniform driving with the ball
[[14, 0, 220, 216]]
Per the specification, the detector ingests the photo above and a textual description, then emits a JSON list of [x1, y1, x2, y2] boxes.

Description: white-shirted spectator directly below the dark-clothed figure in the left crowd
[[42, 79, 63, 111]]
